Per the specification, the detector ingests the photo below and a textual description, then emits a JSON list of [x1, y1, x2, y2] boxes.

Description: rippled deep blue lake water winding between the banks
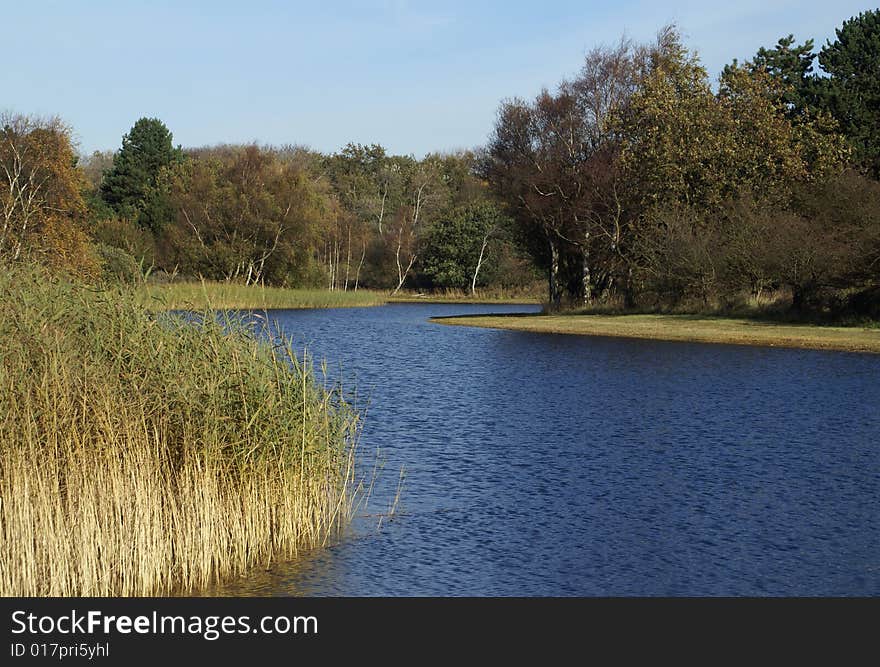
[[211, 304, 880, 596]]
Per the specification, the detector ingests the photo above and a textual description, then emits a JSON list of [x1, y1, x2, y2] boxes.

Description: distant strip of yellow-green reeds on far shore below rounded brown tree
[[138, 282, 388, 311]]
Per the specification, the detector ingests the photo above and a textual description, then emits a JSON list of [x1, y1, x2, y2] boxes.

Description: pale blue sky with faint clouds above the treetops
[[0, 0, 871, 156]]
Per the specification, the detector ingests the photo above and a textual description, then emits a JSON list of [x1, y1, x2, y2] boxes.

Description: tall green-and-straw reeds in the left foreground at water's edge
[[0, 267, 357, 596]]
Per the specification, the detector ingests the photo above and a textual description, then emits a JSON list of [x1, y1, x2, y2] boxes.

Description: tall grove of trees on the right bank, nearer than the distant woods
[[481, 11, 880, 316]]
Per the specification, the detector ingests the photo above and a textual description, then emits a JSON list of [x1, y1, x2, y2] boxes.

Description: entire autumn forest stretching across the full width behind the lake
[[0, 10, 880, 319]]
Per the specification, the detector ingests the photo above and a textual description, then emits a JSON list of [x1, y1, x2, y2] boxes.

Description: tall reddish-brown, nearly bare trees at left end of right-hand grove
[[487, 40, 648, 306]]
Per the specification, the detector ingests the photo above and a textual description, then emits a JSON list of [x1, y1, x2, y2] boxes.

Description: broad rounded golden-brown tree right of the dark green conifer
[[160, 145, 331, 285]]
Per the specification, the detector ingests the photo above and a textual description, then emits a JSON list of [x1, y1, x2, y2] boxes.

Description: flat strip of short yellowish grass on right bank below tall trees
[[435, 315, 880, 353]]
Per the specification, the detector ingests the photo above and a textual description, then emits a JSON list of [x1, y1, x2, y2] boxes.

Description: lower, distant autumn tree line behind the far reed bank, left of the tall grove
[[0, 114, 536, 292]]
